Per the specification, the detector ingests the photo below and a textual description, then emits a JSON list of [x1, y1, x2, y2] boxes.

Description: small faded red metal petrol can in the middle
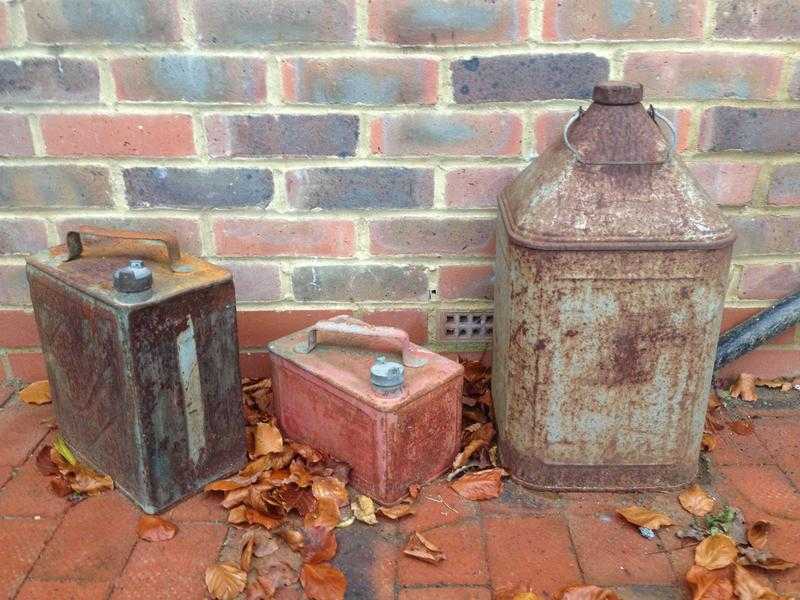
[[269, 316, 464, 504]]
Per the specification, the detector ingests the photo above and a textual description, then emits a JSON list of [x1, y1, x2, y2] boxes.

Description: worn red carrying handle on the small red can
[[294, 315, 428, 367]]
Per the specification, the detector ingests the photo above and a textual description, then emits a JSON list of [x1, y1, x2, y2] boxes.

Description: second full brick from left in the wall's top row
[[195, 0, 356, 46]]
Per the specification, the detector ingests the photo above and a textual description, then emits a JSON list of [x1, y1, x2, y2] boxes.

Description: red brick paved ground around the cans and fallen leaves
[[0, 386, 800, 600]]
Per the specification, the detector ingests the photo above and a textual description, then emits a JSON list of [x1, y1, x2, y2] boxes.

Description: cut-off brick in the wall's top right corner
[[713, 0, 800, 40]]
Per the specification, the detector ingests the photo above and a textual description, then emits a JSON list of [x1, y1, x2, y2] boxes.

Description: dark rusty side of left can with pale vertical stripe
[[130, 282, 246, 510]]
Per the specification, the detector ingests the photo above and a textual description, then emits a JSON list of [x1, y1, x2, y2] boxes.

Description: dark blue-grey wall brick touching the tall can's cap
[[451, 53, 608, 103]]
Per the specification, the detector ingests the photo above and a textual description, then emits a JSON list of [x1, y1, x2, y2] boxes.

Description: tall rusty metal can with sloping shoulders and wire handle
[[492, 82, 734, 490]]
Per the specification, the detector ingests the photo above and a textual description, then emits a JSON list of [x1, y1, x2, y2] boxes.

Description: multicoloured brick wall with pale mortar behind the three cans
[[0, 0, 800, 379]]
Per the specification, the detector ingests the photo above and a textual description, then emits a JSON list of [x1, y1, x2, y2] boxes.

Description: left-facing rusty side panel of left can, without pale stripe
[[28, 266, 142, 490]]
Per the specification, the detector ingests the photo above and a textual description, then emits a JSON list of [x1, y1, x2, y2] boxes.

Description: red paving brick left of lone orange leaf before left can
[[31, 492, 144, 581]]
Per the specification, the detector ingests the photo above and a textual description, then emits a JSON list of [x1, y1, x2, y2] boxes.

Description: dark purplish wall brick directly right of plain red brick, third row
[[204, 114, 358, 157]]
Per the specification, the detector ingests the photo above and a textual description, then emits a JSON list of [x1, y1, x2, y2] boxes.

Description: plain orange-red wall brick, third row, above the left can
[[40, 114, 195, 157]]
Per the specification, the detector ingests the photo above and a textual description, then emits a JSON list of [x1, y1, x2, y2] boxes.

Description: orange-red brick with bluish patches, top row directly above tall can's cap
[[542, 0, 704, 41]]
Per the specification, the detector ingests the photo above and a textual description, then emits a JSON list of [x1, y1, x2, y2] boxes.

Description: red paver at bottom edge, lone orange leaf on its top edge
[[111, 523, 228, 600]]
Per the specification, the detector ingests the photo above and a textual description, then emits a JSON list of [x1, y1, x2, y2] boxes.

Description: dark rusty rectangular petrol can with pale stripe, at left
[[28, 227, 245, 513]]
